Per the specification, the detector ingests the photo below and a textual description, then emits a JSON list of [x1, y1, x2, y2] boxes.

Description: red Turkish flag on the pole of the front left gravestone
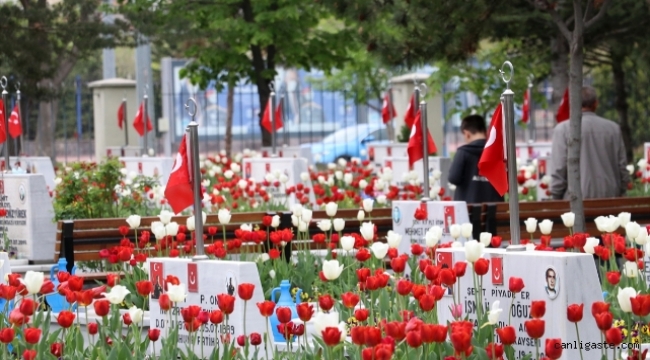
[[165, 134, 194, 214]]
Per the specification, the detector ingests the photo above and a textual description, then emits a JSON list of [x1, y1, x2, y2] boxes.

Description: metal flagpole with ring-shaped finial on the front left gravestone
[[185, 98, 208, 261]]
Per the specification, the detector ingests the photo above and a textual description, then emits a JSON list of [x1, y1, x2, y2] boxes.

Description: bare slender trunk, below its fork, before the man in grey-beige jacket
[[567, 22, 585, 232]]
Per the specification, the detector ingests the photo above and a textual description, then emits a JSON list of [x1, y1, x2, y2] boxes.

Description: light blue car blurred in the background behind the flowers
[[301, 123, 388, 164]]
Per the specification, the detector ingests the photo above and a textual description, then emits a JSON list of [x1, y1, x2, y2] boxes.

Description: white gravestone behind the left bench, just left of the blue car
[[242, 158, 315, 209]]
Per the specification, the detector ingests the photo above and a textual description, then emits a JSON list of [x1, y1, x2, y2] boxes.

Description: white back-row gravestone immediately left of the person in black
[[382, 156, 451, 196]]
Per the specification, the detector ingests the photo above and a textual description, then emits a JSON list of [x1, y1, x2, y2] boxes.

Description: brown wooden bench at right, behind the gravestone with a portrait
[[481, 197, 650, 246]]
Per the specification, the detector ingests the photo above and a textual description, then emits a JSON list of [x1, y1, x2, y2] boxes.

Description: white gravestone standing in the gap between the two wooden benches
[[392, 200, 469, 254]]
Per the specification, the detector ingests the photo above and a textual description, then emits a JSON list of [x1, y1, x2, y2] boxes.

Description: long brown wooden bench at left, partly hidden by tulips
[[54, 205, 393, 281]]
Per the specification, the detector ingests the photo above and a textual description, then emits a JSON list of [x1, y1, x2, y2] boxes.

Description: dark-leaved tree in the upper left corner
[[0, 0, 125, 159]]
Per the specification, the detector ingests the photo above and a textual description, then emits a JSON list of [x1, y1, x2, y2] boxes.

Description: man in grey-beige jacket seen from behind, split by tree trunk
[[550, 86, 630, 200]]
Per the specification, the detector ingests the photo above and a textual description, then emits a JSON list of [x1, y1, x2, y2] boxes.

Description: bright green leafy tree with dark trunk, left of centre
[[121, 0, 353, 146]]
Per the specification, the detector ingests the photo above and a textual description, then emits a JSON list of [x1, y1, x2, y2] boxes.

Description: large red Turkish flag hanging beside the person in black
[[478, 103, 508, 196]]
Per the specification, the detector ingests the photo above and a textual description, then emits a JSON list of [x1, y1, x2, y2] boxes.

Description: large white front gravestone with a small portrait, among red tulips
[[436, 248, 603, 360]]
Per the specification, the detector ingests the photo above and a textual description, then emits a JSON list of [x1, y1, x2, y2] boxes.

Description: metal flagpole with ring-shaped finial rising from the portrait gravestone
[[499, 61, 520, 245]]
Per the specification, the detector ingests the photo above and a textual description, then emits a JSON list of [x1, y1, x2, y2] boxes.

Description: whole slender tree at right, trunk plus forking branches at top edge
[[528, 0, 612, 232]]
